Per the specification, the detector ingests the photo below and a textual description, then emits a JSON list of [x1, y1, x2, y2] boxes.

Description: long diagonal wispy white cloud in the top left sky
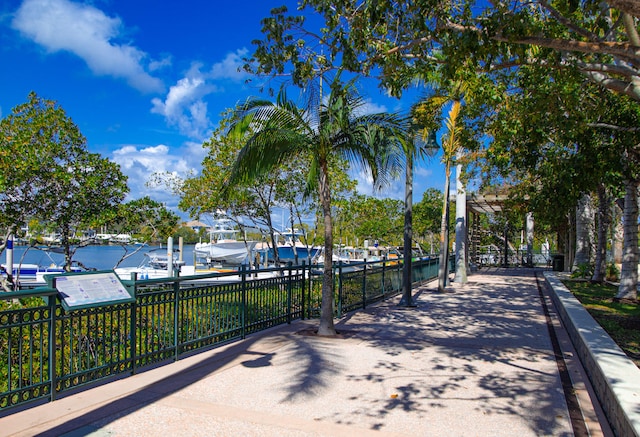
[[12, 0, 164, 92]]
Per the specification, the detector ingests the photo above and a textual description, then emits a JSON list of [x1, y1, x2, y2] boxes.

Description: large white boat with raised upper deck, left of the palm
[[194, 219, 257, 265]]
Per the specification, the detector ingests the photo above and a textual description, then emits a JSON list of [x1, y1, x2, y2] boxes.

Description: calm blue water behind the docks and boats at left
[[5, 243, 194, 270]]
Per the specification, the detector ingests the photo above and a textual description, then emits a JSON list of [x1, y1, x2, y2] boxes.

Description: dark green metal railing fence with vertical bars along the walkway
[[0, 259, 438, 415]]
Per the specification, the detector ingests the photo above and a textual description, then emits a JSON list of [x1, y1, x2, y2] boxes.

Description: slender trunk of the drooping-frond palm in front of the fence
[[318, 162, 336, 335]]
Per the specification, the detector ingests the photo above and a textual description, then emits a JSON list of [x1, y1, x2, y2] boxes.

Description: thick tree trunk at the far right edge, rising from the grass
[[616, 180, 638, 299]]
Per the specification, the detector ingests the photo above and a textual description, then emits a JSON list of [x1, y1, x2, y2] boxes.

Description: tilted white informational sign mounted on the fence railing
[[55, 271, 135, 311]]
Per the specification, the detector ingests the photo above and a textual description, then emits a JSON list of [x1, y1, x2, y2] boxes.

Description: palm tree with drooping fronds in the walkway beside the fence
[[230, 74, 406, 335]]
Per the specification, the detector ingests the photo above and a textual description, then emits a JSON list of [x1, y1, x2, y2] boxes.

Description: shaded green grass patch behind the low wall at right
[[564, 280, 640, 367]]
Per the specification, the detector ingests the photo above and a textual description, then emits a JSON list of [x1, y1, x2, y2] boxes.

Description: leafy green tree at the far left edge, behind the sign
[[0, 93, 128, 269]]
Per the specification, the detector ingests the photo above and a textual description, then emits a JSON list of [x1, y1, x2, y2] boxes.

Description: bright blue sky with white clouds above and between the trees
[[0, 0, 444, 219]]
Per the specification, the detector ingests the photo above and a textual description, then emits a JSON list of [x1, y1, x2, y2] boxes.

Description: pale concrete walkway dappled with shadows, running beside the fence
[[0, 269, 610, 437]]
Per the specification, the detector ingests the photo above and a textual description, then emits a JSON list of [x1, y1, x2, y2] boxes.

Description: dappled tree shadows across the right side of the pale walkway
[[276, 270, 571, 435]]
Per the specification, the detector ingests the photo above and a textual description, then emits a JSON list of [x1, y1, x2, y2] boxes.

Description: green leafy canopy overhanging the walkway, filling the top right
[[247, 0, 640, 242]]
